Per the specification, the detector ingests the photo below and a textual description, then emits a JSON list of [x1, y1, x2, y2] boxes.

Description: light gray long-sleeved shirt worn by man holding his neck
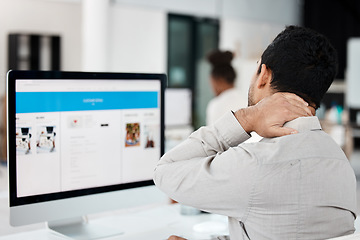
[[154, 112, 356, 240]]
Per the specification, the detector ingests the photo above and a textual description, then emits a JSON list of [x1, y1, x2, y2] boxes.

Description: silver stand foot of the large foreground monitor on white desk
[[47, 217, 124, 240]]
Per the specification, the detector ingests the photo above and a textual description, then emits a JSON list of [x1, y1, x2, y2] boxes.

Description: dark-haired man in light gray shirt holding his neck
[[154, 26, 356, 240]]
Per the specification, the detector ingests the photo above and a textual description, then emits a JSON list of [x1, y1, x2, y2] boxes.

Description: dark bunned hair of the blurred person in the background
[[207, 50, 236, 84]]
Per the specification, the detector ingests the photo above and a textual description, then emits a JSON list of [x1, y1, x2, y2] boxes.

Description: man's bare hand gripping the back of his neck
[[235, 93, 312, 138]]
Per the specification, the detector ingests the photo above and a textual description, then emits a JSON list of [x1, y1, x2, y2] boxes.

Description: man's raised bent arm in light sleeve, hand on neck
[[154, 93, 309, 217]]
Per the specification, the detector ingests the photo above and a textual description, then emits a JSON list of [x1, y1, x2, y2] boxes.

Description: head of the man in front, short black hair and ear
[[248, 26, 337, 108]]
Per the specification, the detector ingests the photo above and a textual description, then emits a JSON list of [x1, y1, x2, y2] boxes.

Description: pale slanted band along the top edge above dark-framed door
[[113, 0, 302, 24]]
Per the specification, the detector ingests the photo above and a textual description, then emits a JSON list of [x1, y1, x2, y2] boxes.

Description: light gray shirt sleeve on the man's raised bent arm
[[154, 111, 257, 218]]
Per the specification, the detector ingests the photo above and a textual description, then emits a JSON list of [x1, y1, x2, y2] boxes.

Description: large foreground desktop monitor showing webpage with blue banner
[[7, 71, 166, 239]]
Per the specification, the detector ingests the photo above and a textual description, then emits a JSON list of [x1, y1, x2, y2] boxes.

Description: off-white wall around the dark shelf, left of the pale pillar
[[0, 0, 81, 96]]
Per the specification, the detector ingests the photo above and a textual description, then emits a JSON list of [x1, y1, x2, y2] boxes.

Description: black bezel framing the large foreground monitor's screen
[[6, 70, 167, 207]]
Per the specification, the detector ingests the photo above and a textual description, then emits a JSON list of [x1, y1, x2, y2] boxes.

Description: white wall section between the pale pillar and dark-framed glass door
[[108, 4, 167, 73]]
